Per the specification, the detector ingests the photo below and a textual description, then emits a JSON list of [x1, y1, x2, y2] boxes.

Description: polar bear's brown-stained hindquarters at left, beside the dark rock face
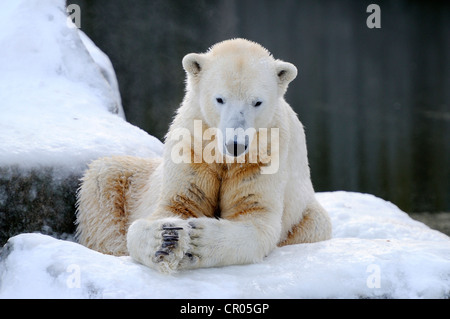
[[76, 156, 160, 256]]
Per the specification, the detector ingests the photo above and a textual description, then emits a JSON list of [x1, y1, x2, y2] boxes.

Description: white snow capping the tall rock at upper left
[[0, 0, 162, 173]]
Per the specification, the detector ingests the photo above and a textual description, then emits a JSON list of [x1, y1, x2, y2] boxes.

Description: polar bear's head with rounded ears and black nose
[[183, 39, 297, 156]]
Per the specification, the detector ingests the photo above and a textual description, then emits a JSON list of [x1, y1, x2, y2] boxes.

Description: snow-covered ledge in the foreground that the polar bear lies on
[[0, 192, 450, 298]]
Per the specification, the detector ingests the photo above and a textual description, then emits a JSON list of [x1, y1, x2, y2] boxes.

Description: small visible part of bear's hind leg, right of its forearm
[[278, 201, 331, 247]]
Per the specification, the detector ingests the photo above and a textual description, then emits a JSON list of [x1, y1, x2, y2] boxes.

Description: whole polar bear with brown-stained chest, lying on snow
[[77, 39, 331, 273]]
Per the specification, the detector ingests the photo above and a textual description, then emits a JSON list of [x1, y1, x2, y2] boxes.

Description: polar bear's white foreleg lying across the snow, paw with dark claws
[[127, 215, 280, 273]]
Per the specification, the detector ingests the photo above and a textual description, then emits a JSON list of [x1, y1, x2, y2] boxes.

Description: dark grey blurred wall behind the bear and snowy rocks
[[67, 0, 450, 212]]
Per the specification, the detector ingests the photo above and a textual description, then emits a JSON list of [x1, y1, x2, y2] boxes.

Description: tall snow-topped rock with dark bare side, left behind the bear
[[0, 0, 162, 244]]
